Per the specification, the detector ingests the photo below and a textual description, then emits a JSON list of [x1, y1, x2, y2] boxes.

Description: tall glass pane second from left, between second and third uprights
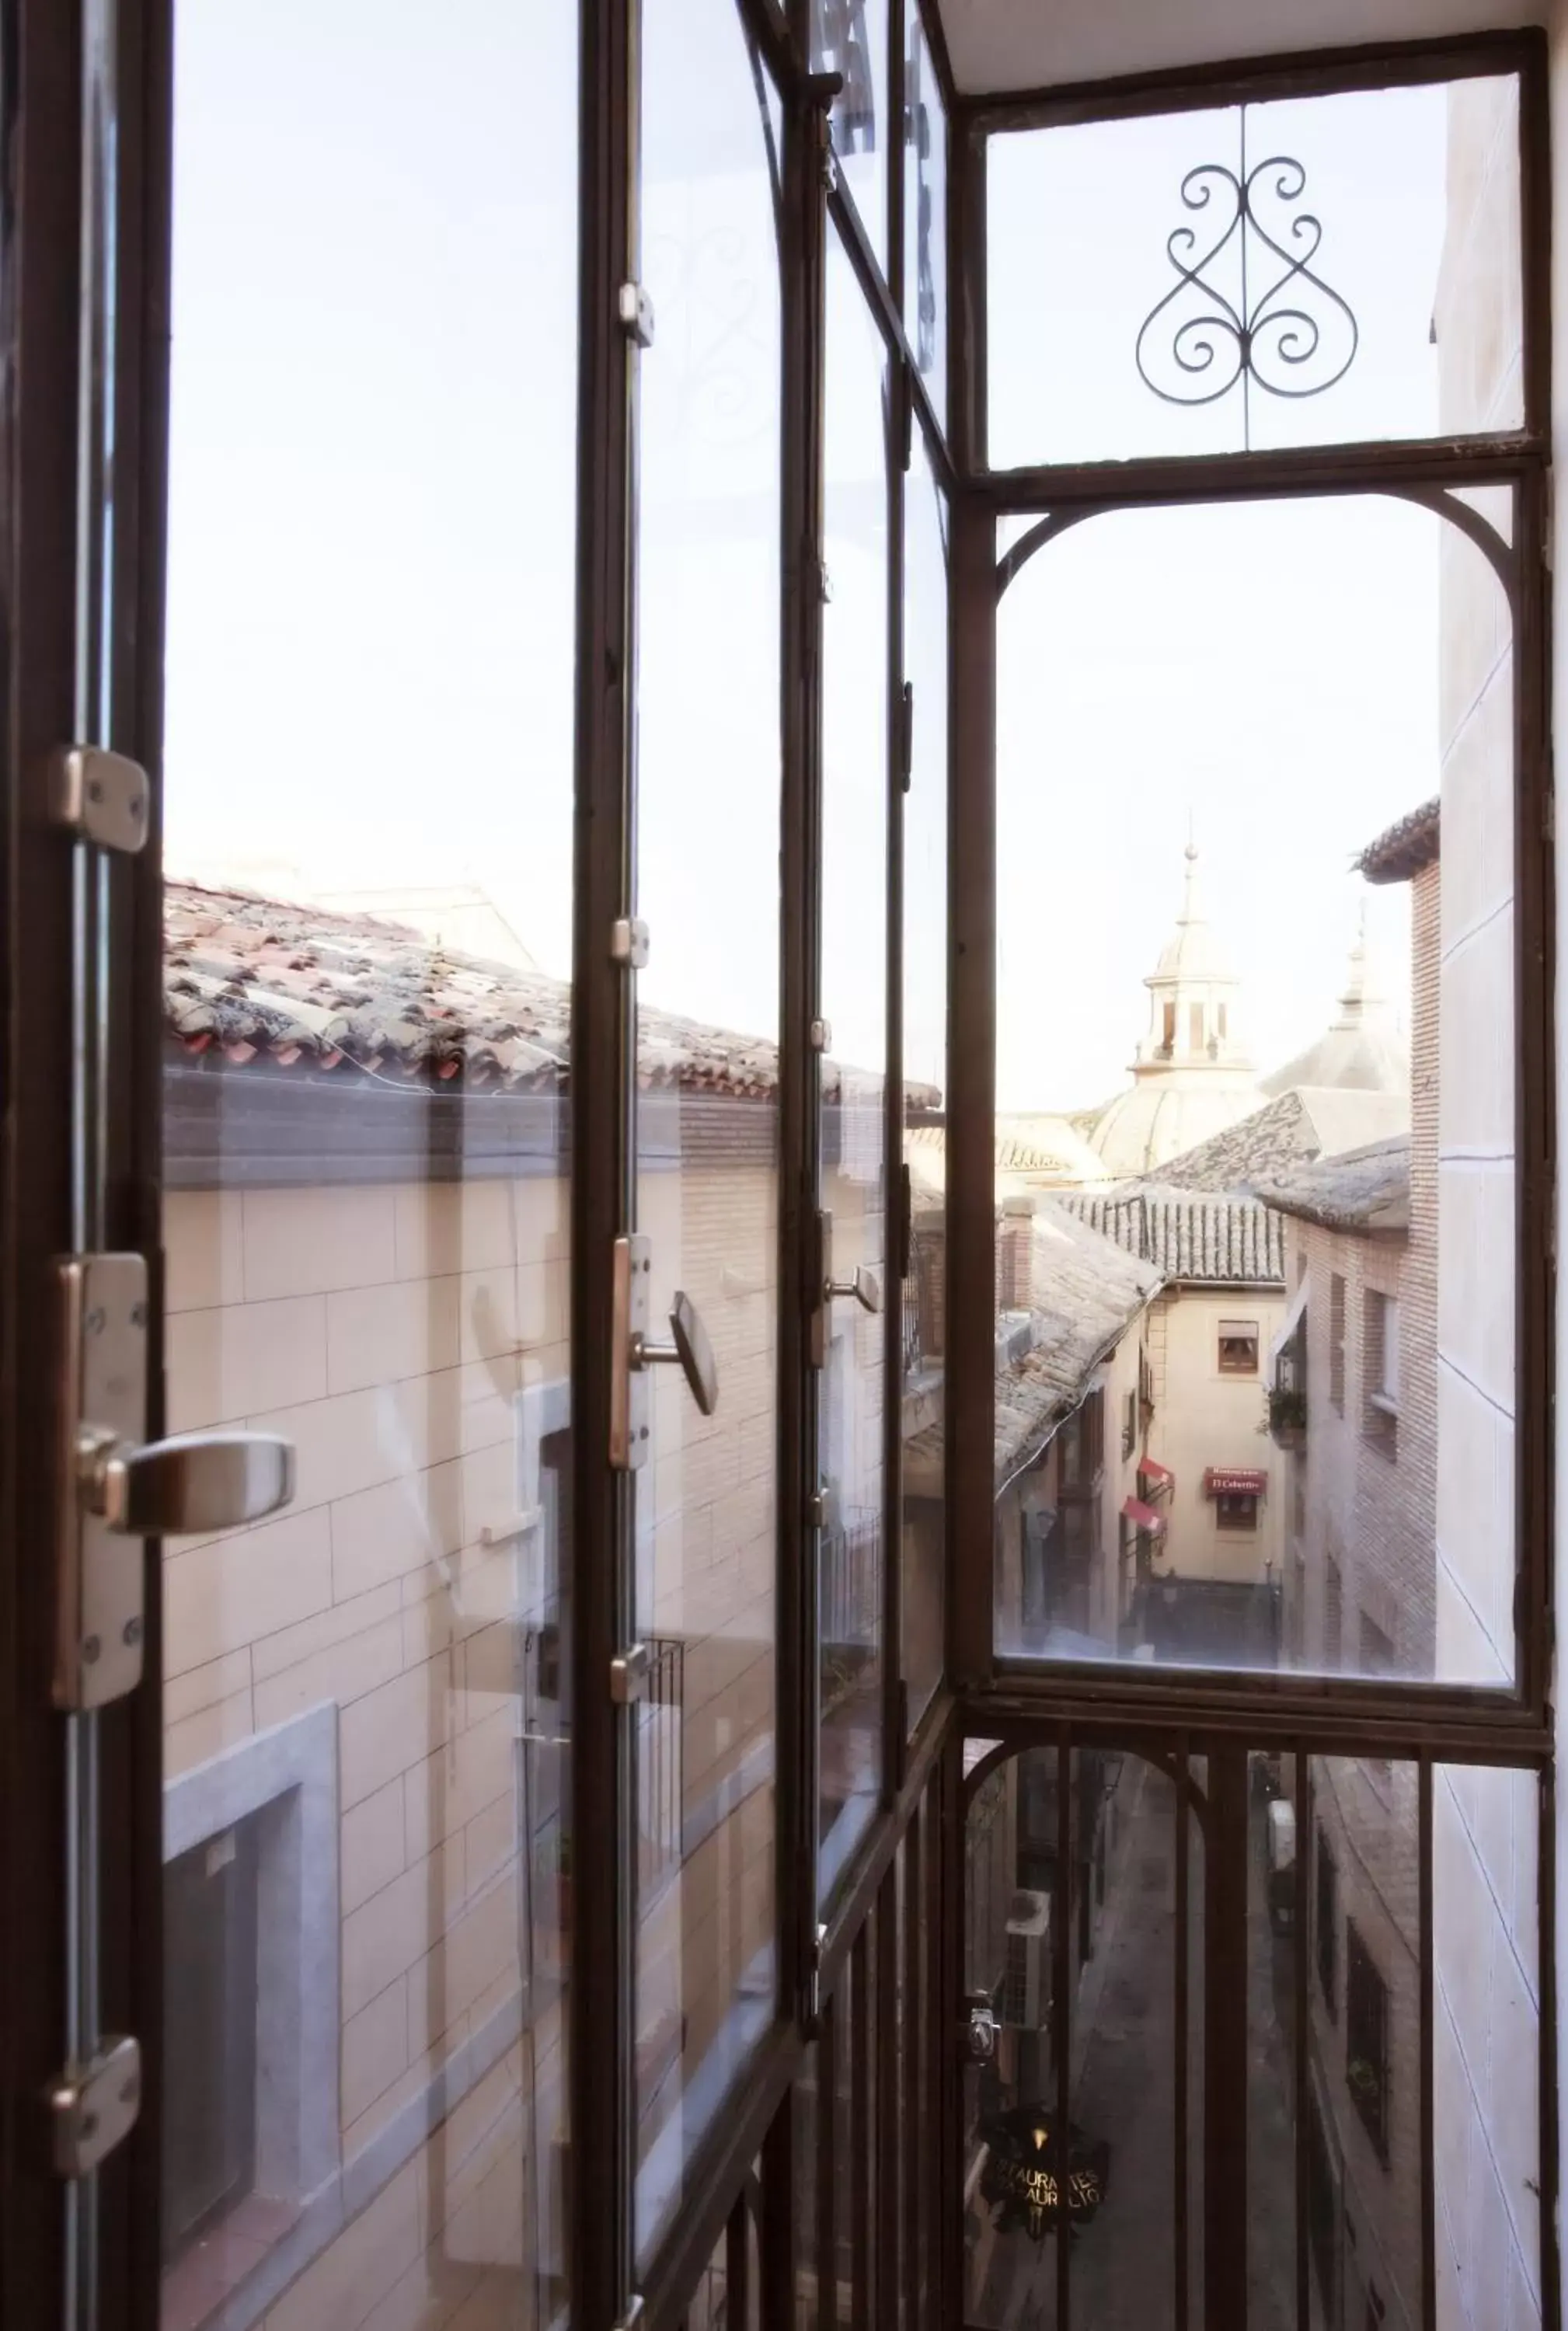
[[636, 0, 781, 2254]]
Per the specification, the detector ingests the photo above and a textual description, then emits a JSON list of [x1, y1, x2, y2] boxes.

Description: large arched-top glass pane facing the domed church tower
[[995, 499, 1517, 1685]]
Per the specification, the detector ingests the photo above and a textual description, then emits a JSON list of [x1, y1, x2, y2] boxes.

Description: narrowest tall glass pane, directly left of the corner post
[[901, 431, 948, 1730]]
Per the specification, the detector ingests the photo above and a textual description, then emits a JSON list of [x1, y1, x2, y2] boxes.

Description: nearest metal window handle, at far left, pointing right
[[79, 1431, 294, 1538]]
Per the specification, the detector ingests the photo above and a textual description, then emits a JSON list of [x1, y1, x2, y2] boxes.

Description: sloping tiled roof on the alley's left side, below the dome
[[995, 1196, 1160, 1485]]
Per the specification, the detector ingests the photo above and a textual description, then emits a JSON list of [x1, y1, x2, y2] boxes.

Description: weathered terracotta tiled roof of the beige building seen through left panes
[[163, 881, 939, 1105]]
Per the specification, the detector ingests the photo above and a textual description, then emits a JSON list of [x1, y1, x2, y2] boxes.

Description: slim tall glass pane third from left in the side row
[[817, 233, 887, 1895]]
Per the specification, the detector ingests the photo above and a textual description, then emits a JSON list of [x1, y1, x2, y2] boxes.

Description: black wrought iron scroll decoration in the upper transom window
[[1134, 107, 1361, 445]]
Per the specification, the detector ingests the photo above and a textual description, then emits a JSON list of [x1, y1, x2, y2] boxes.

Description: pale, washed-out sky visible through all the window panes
[[166, 0, 1519, 1107]]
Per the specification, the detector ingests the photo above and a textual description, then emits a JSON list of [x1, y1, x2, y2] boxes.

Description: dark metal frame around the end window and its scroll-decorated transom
[[948, 30, 1556, 1746]]
